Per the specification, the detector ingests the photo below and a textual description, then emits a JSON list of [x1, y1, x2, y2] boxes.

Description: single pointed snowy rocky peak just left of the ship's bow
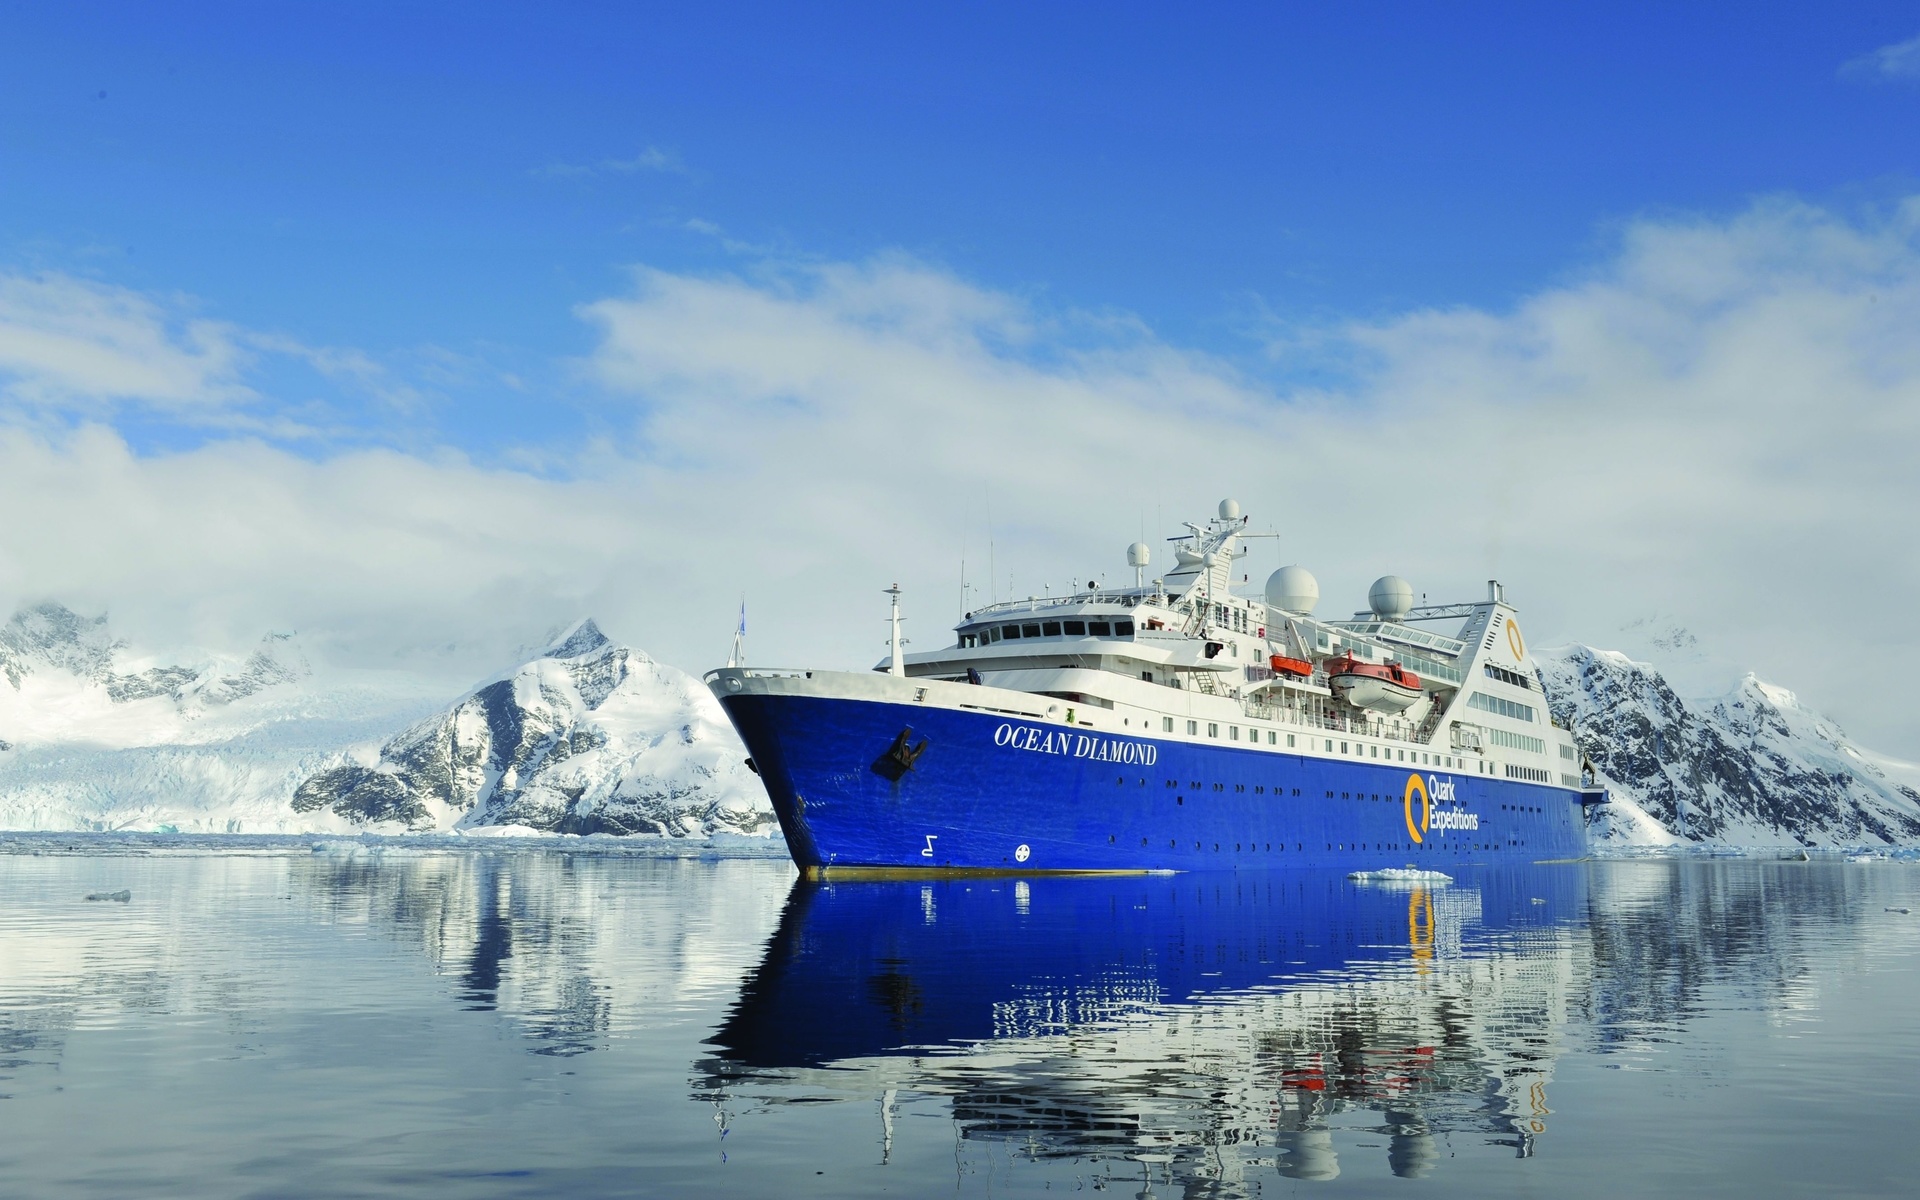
[[292, 620, 774, 835]]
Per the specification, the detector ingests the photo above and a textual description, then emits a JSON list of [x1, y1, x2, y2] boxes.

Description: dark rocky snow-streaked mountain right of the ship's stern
[[1536, 645, 1920, 847]]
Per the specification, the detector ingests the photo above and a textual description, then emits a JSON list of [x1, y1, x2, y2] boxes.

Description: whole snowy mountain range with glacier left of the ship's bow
[[0, 605, 772, 835]]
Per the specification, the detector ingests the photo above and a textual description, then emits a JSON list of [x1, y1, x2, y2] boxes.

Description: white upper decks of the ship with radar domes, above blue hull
[[894, 499, 1590, 787]]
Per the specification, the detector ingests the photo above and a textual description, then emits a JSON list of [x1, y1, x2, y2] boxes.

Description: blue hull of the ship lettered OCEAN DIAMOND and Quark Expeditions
[[720, 693, 1586, 874]]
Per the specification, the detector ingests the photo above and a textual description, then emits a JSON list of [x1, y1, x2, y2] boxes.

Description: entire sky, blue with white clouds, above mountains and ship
[[0, 4, 1920, 753]]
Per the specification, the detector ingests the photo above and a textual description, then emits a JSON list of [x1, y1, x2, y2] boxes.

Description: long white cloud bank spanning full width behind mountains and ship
[[0, 202, 1920, 755]]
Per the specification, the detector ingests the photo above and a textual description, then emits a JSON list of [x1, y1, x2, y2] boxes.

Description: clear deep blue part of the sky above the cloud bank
[[11, 4, 1920, 457]]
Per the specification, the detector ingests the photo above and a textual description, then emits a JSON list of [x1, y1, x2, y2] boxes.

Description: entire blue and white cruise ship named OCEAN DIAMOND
[[707, 499, 1605, 876]]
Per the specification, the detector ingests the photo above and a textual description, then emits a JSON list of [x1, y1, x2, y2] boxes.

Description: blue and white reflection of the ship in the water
[[697, 866, 1590, 1192]]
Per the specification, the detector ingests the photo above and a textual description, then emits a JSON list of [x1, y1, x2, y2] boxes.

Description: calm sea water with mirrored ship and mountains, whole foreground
[[0, 837, 1920, 1198]]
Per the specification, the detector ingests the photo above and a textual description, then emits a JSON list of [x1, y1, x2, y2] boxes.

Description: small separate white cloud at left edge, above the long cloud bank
[[0, 275, 252, 409]]
